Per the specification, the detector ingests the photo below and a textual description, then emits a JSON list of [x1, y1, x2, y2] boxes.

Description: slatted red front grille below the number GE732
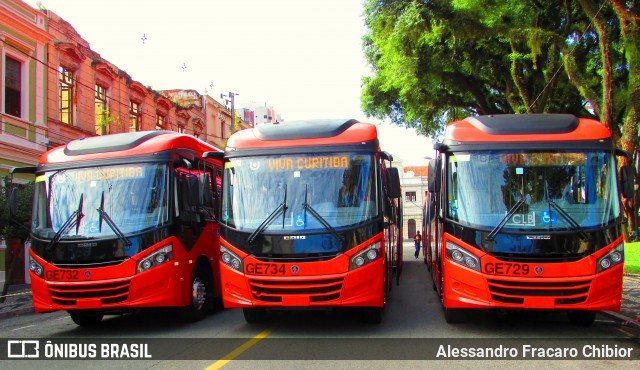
[[49, 281, 129, 306]]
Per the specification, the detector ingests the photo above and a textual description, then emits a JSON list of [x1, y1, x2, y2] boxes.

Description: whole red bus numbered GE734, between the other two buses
[[205, 120, 402, 323]]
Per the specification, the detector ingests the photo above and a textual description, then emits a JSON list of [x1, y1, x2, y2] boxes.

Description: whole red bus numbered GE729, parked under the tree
[[423, 114, 633, 325]]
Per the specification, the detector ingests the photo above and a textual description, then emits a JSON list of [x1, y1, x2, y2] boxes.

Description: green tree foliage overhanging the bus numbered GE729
[[362, 0, 638, 141]]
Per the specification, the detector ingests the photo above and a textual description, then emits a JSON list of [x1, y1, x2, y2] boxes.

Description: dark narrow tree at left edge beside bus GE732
[[0, 177, 34, 302]]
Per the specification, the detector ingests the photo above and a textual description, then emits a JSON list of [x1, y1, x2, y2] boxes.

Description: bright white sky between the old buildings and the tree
[[24, 0, 433, 166]]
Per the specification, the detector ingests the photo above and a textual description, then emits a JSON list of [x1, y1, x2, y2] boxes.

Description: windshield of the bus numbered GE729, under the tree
[[447, 151, 620, 231]]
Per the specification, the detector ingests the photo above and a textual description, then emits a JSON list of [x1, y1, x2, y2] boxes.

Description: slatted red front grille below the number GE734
[[249, 278, 342, 302]]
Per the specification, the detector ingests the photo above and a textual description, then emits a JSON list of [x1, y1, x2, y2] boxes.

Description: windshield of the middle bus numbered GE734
[[222, 153, 378, 234]]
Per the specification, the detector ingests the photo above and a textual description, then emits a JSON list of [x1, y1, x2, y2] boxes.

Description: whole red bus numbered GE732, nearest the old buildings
[[13, 131, 222, 326]]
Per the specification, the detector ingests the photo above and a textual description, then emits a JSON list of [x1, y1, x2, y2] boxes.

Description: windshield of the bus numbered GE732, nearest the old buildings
[[31, 164, 169, 240]]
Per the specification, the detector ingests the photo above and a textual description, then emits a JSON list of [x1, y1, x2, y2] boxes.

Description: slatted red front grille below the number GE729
[[488, 279, 591, 305]]
